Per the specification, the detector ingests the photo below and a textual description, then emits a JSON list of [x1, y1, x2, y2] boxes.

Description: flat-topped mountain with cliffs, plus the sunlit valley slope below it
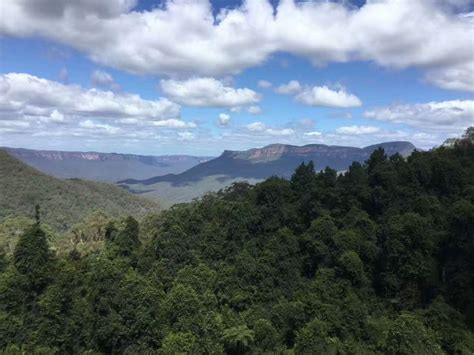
[[118, 142, 415, 205]]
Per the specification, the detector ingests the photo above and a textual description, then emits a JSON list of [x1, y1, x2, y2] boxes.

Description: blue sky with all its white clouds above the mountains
[[0, 0, 474, 155]]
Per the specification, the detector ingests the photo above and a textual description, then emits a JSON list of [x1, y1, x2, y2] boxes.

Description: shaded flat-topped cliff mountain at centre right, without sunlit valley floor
[[122, 142, 415, 185]]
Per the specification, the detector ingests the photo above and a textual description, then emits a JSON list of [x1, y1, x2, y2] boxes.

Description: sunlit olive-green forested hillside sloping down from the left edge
[[0, 149, 158, 230]]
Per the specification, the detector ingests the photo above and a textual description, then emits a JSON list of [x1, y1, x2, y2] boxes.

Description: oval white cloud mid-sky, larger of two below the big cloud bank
[[160, 78, 260, 107]]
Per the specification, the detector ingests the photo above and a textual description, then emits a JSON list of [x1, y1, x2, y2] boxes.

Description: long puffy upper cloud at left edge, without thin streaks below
[[0, 73, 180, 121]]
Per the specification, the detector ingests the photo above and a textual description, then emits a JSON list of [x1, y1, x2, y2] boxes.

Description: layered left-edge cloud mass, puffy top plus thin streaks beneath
[[0, 73, 197, 142]]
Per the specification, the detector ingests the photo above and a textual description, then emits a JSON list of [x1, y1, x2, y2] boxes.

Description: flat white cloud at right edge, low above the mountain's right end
[[364, 100, 474, 132]]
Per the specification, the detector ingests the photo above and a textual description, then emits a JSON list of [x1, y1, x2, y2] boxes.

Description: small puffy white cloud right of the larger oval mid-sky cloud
[[296, 86, 362, 108]]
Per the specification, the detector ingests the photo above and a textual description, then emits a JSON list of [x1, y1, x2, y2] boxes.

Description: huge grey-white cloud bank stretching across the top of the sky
[[0, 0, 474, 88]]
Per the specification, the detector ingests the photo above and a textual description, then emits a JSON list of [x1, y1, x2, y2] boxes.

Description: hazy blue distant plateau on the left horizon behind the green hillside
[[2, 148, 212, 182]]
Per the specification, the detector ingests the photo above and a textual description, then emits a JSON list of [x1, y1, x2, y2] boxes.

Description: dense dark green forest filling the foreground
[[0, 133, 474, 354]]
